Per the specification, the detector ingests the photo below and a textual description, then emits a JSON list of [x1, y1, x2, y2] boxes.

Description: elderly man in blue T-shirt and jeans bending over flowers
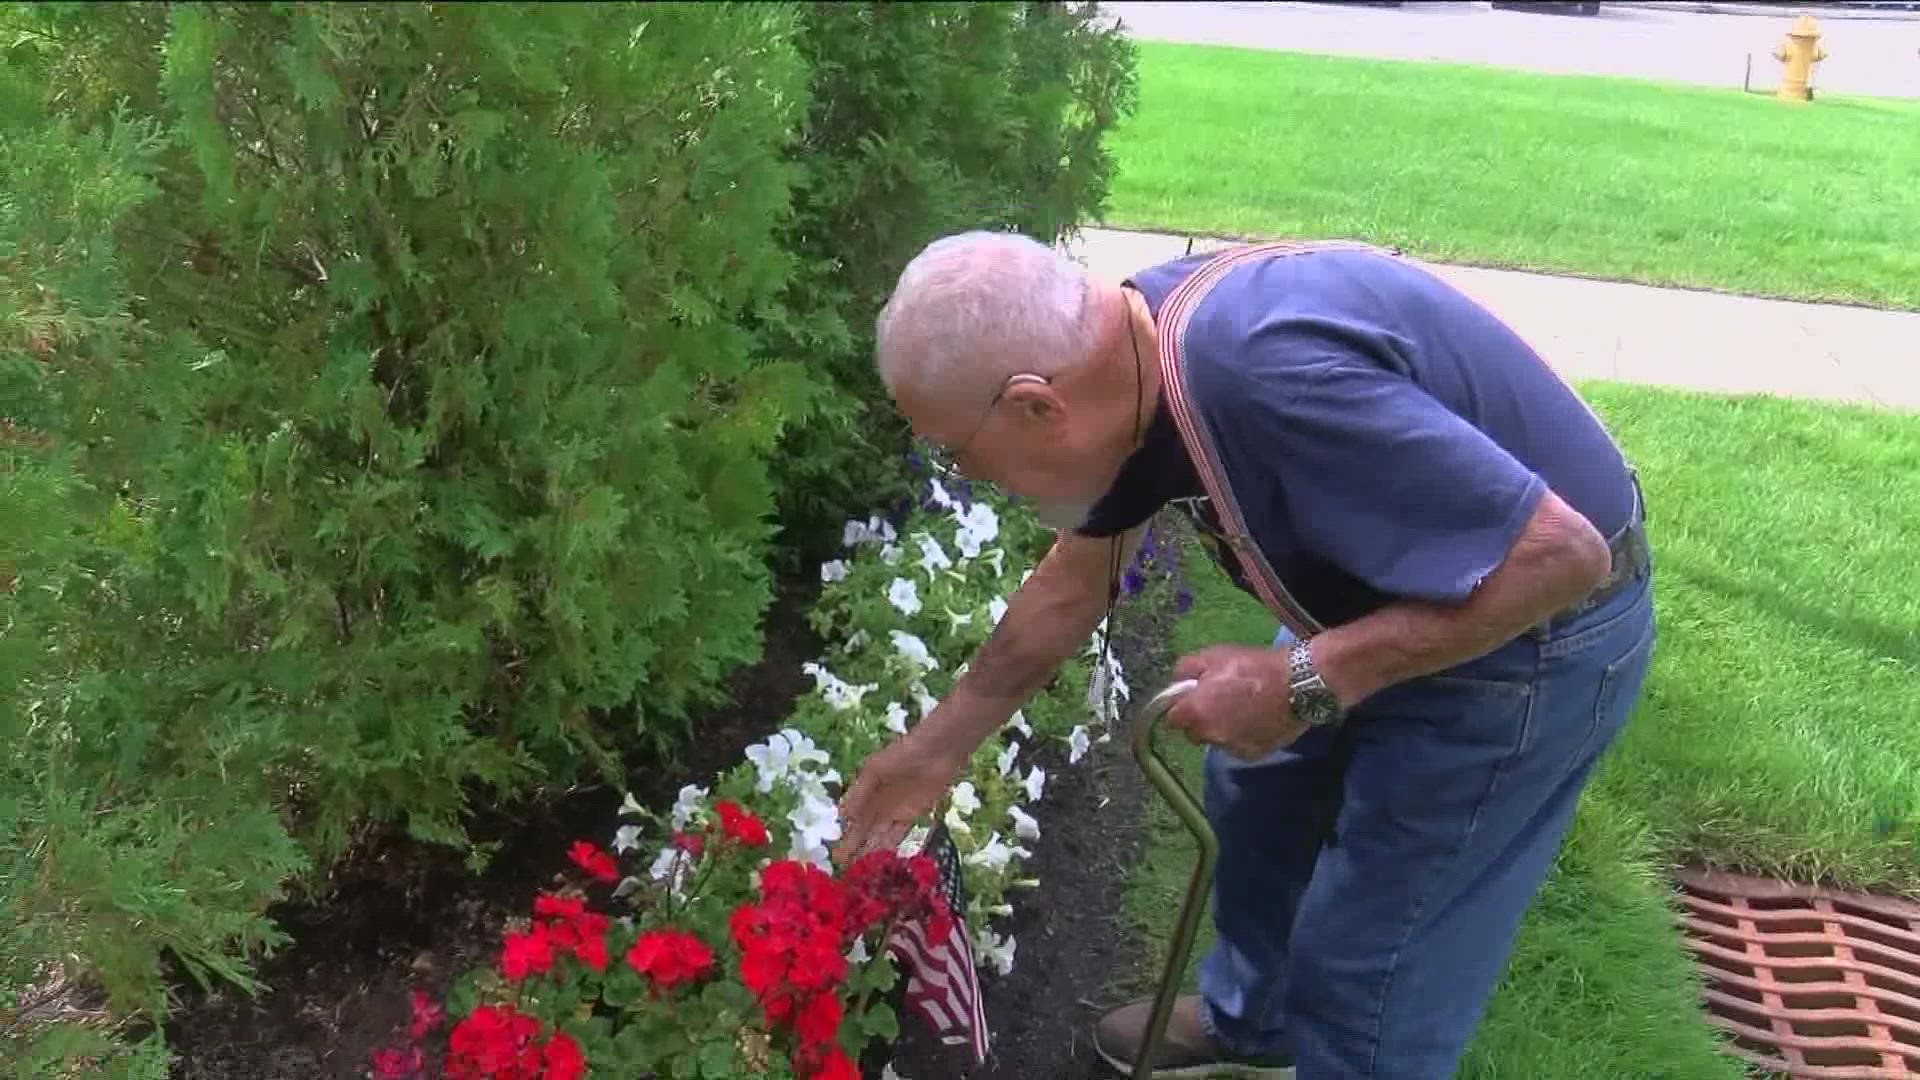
[[841, 233, 1655, 1080]]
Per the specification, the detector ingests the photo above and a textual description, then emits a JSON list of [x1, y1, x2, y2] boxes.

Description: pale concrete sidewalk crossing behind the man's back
[[1073, 229, 1920, 409]]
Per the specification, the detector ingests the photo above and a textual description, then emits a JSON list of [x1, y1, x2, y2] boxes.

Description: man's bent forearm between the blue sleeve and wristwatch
[[1313, 496, 1609, 707]]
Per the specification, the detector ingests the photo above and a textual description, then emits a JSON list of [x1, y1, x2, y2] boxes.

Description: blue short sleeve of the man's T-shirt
[[1210, 323, 1546, 603]]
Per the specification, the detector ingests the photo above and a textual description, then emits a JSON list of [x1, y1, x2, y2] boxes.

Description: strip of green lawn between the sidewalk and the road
[[1106, 42, 1920, 309]]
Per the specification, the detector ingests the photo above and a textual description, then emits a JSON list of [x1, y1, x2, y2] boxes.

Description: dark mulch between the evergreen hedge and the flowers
[[167, 588, 820, 1080]]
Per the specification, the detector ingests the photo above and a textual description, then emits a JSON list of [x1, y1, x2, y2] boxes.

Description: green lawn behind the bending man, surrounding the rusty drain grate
[[1127, 384, 1920, 1080]]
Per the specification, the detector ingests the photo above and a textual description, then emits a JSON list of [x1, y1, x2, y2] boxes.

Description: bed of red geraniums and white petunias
[[374, 480, 1139, 1080]]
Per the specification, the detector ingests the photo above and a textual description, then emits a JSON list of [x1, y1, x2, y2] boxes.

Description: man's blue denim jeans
[[1200, 578, 1655, 1080]]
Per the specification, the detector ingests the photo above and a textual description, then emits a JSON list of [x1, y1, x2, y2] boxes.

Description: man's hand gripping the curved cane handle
[[1167, 646, 1308, 761]]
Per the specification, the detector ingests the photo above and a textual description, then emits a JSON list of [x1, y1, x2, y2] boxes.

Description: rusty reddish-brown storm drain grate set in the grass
[[1680, 871, 1920, 1080]]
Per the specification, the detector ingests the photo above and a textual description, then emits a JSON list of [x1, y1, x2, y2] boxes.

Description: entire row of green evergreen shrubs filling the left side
[[0, 4, 1133, 1053]]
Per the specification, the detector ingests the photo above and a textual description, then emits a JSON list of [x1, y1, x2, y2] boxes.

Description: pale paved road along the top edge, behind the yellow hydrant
[[1106, 2, 1920, 98]]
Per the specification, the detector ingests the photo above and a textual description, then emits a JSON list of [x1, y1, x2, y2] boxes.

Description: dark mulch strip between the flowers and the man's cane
[[868, 584, 1173, 1080]]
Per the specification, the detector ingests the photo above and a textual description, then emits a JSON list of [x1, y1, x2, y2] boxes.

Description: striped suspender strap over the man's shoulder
[[1158, 242, 1379, 640]]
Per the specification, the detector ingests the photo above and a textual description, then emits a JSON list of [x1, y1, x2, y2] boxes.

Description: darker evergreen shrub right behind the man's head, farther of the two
[[776, 4, 1135, 559]]
